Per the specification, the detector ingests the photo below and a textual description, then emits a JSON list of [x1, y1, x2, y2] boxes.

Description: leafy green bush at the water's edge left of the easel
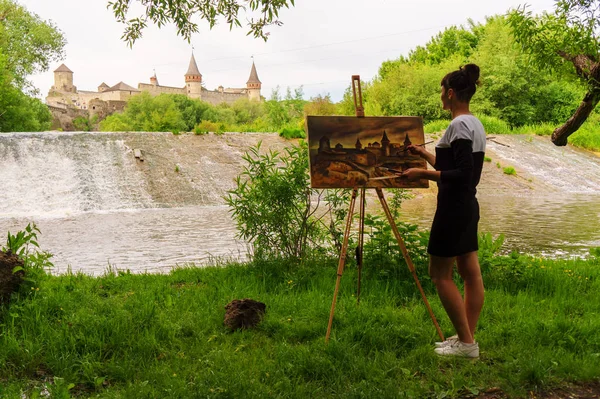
[[226, 141, 330, 259]]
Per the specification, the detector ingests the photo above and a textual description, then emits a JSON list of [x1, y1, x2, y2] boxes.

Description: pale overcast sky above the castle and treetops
[[17, 0, 554, 102]]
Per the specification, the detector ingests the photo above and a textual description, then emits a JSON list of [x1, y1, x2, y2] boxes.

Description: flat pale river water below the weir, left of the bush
[[0, 206, 247, 275]]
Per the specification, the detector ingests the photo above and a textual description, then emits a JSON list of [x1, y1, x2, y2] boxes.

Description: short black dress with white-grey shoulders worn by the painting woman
[[427, 115, 485, 257]]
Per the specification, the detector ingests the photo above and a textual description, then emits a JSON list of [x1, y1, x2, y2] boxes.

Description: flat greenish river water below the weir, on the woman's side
[[403, 193, 600, 256]]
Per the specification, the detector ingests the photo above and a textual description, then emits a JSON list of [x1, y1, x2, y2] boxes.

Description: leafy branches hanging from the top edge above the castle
[[108, 0, 295, 46]]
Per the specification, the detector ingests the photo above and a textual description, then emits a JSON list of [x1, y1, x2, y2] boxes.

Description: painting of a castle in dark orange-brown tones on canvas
[[306, 116, 429, 188]]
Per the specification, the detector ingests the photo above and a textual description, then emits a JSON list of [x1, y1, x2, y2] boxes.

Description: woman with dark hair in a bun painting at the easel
[[402, 64, 485, 357]]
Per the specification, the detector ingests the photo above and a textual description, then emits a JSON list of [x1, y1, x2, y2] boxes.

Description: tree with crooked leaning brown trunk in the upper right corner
[[509, 0, 600, 145]]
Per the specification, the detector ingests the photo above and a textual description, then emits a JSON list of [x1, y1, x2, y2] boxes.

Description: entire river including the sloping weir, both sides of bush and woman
[[0, 133, 600, 275]]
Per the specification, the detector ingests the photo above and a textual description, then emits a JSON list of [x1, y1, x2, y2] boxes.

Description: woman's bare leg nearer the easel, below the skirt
[[429, 255, 474, 344]]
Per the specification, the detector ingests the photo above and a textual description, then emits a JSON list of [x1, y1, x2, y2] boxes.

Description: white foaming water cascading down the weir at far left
[[0, 132, 153, 217]]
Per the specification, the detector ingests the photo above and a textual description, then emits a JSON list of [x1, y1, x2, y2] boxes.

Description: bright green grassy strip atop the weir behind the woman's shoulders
[[425, 114, 600, 152]]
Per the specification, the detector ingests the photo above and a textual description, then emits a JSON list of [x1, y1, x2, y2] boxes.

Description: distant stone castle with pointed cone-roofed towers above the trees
[[46, 53, 261, 116]]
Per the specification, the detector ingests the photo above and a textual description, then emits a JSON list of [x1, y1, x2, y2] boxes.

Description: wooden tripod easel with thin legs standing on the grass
[[325, 75, 444, 342]]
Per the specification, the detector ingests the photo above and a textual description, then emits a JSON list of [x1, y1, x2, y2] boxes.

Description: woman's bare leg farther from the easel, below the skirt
[[456, 251, 484, 335]]
